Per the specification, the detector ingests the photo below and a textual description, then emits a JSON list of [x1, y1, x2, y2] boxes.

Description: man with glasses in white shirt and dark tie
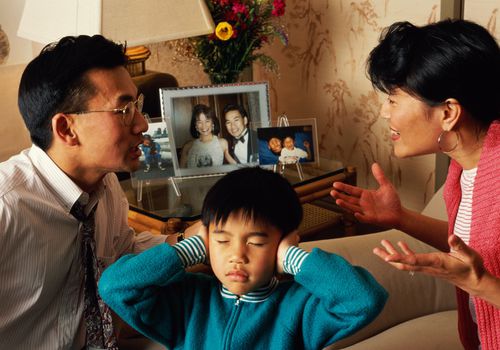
[[0, 35, 182, 350]]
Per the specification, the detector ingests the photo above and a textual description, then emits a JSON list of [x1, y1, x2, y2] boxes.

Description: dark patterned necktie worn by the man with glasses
[[71, 202, 118, 350]]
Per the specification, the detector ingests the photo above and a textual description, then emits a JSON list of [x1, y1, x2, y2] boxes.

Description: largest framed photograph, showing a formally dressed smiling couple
[[160, 82, 271, 177]]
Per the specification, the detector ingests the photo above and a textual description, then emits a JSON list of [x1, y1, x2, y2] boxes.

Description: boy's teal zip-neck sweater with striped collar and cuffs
[[99, 237, 387, 350]]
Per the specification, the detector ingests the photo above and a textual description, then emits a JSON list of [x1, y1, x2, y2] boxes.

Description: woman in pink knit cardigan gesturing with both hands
[[332, 20, 500, 350]]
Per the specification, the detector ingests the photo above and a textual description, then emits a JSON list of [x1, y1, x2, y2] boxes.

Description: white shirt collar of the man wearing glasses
[[28, 145, 104, 214]]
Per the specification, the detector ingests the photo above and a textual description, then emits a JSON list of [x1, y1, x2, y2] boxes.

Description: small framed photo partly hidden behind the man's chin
[[133, 118, 174, 180]]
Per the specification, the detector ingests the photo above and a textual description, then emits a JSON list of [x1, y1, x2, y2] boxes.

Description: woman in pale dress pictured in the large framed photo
[[180, 104, 236, 168]]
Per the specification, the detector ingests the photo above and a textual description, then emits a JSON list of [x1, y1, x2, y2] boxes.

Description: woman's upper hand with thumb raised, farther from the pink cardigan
[[330, 163, 403, 228]]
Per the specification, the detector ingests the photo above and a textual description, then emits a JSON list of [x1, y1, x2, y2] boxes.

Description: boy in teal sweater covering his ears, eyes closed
[[99, 168, 387, 350]]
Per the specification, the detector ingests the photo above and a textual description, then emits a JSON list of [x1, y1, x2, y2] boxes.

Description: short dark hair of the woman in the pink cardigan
[[368, 20, 500, 128]]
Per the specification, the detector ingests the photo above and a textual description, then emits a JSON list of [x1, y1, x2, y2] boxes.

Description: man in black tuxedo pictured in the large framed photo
[[223, 104, 258, 163]]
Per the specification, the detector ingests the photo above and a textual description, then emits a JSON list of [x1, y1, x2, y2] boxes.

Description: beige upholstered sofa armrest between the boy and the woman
[[300, 230, 456, 349]]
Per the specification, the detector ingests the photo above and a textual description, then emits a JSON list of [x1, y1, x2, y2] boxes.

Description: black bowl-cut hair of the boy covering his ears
[[201, 167, 302, 235]]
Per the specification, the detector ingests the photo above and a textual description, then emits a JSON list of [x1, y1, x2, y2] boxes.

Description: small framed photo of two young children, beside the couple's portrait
[[257, 125, 314, 165]]
